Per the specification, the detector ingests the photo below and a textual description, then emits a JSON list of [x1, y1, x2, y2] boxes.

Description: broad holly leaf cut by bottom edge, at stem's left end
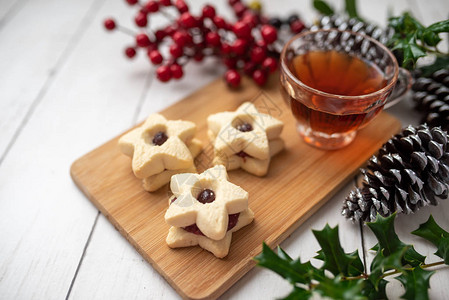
[[315, 275, 367, 300]]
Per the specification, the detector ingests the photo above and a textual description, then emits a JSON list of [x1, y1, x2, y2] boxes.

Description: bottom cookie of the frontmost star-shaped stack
[[166, 208, 254, 258]]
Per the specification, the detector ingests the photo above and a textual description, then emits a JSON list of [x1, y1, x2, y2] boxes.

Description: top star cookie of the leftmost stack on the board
[[119, 114, 196, 179]]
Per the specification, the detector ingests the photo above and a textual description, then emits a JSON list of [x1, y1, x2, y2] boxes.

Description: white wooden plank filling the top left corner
[[0, 0, 99, 163]]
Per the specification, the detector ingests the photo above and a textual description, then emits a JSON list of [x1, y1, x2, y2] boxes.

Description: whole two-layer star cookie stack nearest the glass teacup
[[207, 102, 284, 176]]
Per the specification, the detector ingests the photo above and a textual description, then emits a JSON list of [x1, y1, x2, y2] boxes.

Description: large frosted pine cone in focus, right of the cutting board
[[342, 124, 449, 221]]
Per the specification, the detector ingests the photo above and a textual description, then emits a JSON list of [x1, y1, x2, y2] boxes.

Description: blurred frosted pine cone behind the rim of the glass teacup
[[311, 15, 394, 44]]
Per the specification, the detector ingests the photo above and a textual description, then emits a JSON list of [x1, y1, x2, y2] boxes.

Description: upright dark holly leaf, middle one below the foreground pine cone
[[366, 213, 426, 266]]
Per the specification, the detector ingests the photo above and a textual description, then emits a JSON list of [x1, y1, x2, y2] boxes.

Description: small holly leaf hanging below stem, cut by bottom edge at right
[[397, 267, 435, 300]]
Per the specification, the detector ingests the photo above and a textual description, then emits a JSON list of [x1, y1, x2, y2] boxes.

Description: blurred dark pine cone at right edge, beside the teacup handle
[[412, 69, 449, 131]]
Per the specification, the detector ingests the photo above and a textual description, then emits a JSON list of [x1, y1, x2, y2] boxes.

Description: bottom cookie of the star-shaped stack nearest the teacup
[[212, 138, 284, 176]]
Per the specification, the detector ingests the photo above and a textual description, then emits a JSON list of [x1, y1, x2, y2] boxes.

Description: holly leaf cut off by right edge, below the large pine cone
[[412, 215, 449, 264]]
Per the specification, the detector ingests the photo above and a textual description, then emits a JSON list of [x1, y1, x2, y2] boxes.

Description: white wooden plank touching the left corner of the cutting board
[[0, 1, 151, 299]]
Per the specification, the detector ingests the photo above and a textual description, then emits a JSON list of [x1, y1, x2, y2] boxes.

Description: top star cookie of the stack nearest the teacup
[[207, 102, 283, 160]]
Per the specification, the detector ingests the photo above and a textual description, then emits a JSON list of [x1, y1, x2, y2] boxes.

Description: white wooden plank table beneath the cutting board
[[0, 0, 449, 299]]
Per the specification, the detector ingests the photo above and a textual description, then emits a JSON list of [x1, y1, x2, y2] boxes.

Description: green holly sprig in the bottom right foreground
[[254, 214, 449, 300]]
